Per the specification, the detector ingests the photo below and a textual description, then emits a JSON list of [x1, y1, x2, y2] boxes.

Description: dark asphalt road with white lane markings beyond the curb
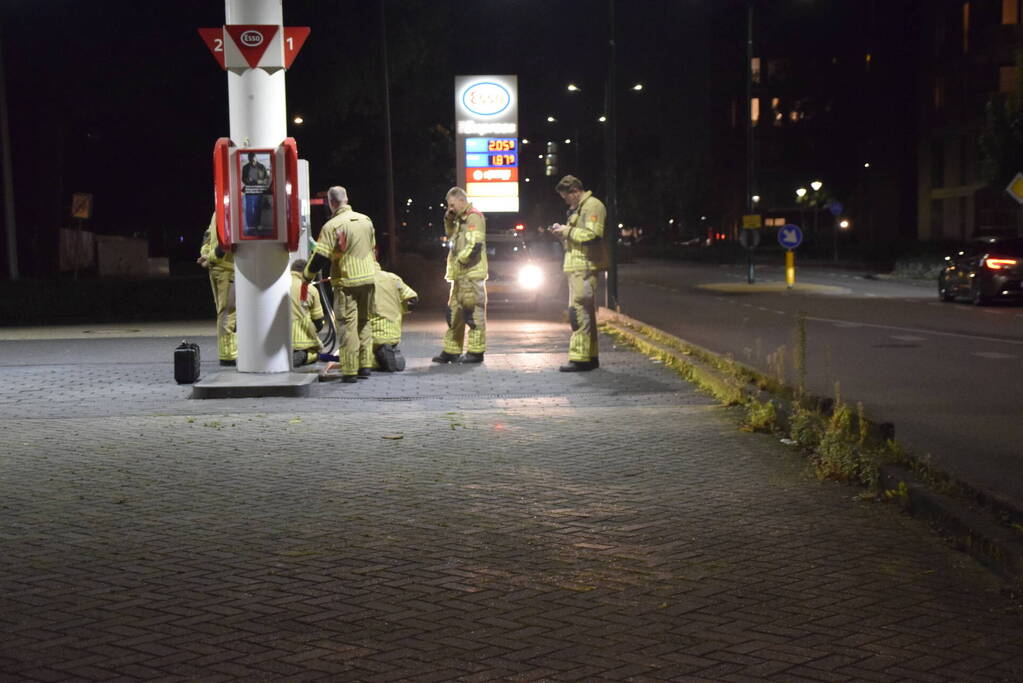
[[620, 260, 1023, 506]]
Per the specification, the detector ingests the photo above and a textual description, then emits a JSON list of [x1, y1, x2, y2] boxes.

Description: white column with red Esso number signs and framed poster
[[199, 0, 309, 373]]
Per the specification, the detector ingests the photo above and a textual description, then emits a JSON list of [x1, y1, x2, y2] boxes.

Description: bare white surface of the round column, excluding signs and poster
[[225, 0, 292, 372]]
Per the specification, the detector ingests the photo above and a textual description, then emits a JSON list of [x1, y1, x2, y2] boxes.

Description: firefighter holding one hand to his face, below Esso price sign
[[433, 187, 487, 363]]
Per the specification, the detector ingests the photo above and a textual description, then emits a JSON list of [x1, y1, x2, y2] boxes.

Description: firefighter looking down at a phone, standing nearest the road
[[551, 176, 608, 372]]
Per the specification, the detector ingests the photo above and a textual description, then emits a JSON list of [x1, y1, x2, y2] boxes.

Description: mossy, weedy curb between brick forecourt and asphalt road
[[597, 307, 1023, 581]]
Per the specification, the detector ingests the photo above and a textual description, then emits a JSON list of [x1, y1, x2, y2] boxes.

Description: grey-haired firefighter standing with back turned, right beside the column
[[303, 185, 379, 382]]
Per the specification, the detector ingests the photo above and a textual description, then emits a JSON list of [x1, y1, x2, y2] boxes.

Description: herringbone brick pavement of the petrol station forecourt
[[0, 316, 1023, 681]]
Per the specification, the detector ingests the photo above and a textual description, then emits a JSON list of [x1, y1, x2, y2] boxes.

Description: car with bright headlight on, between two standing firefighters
[[487, 233, 558, 309]]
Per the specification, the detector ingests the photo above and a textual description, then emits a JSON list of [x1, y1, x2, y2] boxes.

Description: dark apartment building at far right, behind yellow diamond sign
[[917, 0, 1023, 242]]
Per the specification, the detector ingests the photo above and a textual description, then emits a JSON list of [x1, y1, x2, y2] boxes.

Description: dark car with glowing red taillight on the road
[[938, 237, 1023, 306]]
